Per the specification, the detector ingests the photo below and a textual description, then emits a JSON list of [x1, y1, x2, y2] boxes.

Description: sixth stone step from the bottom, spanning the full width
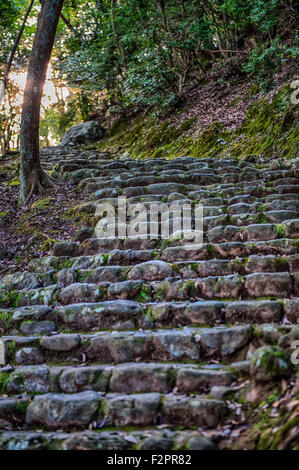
[[0, 265, 299, 308]]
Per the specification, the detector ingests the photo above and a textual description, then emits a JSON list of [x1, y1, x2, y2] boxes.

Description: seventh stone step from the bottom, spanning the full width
[[4, 255, 299, 292]]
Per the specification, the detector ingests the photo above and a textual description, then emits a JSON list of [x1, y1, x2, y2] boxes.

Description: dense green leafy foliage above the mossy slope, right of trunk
[[52, 0, 298, 116]]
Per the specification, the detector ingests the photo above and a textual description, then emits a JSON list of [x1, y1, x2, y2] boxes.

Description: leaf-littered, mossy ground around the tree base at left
[[0, 156, 83, 276]]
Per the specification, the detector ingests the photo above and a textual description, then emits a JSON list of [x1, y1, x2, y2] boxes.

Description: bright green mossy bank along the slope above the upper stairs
[[90, 84, 299, 159]]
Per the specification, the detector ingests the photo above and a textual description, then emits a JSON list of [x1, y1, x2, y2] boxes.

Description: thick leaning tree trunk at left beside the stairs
[[20, 0, 63, 203]]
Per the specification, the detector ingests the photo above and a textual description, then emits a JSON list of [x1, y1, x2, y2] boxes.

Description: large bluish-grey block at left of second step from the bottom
[[26, 391, 100, 428]]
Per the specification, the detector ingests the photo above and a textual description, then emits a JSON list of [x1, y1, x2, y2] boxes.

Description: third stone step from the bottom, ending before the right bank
[[2, 363, 235, 395]]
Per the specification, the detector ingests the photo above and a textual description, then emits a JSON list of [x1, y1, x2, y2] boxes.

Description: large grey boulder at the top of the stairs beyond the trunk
[[61, 121, 105, 147]]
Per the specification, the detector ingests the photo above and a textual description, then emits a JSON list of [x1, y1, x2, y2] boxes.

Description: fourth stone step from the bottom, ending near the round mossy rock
[[1, 324, 253, 365]]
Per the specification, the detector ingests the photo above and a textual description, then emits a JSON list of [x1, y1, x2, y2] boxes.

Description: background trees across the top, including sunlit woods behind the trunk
[[0, 0, 299, 153]]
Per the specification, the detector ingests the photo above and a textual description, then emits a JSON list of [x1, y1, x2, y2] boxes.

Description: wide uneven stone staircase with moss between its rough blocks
[[0, 148, 299, 450]]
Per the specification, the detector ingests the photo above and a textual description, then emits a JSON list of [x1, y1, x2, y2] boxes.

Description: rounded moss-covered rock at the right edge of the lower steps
[[250, 346, 292, 384]]
